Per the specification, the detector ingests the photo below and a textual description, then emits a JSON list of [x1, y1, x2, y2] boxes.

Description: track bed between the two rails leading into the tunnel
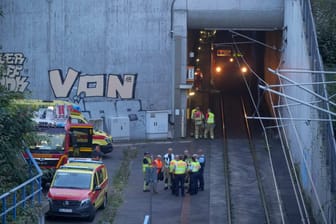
[[221, 92, 271, 223]]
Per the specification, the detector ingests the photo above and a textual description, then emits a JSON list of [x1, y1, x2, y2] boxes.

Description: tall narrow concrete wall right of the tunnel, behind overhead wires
[[280, 1, 331, 223]]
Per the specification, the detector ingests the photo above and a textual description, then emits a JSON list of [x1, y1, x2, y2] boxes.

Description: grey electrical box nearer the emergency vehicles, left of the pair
[[107, 117, 130, 141]]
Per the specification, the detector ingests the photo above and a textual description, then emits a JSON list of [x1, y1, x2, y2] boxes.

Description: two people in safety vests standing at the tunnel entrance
[[190, 106, 215, 139]]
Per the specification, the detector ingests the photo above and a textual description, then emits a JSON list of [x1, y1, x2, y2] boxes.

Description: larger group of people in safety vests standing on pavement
[[142, 148, 205, 197]]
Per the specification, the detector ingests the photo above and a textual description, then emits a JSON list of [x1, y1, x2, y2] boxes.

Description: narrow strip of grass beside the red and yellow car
[[99, 148, 137, 224]]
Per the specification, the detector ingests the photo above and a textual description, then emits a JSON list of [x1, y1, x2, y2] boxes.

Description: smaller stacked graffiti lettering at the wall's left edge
[[0, 52, 29, 92]]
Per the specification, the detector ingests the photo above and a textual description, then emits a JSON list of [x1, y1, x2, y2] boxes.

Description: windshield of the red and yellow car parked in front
[[52, 172, 92, 189]]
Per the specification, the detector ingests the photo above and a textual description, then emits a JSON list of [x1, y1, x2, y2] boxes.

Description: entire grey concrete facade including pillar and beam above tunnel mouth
[[0, 0, 283, 138]]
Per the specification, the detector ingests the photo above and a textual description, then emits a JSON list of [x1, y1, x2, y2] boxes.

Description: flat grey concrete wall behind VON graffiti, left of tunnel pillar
[[0, 0, 172, 139]]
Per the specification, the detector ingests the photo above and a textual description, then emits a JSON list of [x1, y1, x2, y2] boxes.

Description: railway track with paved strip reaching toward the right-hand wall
[[214, 91, 313, 224]]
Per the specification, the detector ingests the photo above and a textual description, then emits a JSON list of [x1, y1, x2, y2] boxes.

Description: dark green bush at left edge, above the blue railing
[[0, 89, 33, 194]]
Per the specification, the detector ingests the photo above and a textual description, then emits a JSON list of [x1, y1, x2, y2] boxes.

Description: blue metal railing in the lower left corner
[[0, 149, 42, 224]]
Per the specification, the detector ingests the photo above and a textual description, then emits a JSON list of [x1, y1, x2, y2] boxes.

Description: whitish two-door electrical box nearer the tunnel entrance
[[146, 111, 168, 139]]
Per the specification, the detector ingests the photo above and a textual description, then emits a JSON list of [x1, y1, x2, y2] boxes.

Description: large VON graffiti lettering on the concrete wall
[[49, 68, 137, 99]]
